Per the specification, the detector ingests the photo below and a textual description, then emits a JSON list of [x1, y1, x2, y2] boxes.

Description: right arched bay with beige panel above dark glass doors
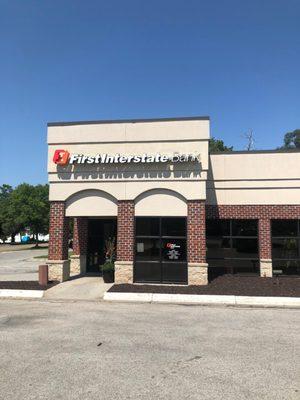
[[134, 189, 188, 284]]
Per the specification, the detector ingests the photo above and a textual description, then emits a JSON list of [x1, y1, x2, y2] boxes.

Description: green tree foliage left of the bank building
[[0, 183, 49, 241]]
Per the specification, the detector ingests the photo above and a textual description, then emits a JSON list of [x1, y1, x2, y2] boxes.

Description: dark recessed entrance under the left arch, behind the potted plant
[[86, 218, 117, 274]]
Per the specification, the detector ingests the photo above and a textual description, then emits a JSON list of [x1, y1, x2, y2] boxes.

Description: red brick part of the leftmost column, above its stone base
[[48, 201, 69, 260]]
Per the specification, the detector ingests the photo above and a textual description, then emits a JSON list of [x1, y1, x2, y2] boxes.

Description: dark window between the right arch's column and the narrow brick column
[[206, 219, 259, 276]]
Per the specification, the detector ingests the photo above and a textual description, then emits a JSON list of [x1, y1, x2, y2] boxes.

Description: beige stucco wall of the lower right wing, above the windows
[[207, 152, 300, 205]]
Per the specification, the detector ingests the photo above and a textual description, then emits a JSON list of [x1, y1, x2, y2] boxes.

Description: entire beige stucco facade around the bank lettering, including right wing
[[48, 119, 300, 208]]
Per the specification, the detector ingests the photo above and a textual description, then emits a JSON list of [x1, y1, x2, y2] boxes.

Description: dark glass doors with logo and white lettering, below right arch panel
[[134, 217, 187, 283]]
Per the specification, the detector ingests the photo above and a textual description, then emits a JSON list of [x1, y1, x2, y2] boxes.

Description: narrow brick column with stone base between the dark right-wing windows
[[258, 218, 273, 277]]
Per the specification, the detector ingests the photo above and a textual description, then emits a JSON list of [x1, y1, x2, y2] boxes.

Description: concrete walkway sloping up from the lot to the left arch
[[44, 276, 113, 300]]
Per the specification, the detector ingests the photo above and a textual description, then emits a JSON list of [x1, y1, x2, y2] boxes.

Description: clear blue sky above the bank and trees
[[0, 0, 300, 185]]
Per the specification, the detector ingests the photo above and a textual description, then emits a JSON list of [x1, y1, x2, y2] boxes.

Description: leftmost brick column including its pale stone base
[[47, 201, 70, 282]]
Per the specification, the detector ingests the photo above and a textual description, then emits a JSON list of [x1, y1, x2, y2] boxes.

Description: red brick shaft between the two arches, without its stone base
[[117, 200, 134, 261]]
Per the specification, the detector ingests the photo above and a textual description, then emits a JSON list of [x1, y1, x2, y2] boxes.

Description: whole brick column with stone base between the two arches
[[115, 200, 134, 283]]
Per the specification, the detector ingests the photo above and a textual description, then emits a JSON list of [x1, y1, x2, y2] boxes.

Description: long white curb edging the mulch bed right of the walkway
[[103, 292, 300, 308]]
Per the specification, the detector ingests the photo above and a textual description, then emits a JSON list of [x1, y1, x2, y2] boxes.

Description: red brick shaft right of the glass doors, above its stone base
[[187, 200, 206, 263]]
